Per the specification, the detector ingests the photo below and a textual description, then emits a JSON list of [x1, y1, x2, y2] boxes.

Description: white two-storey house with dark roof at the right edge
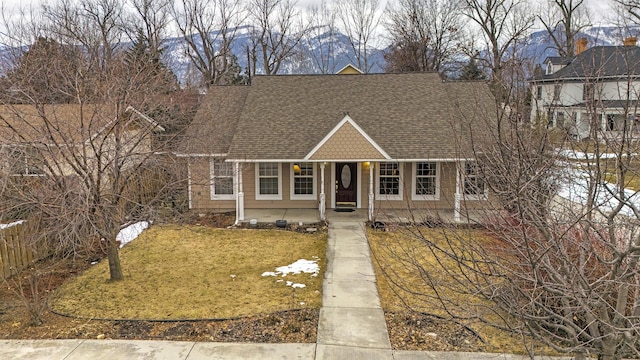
[[530, 38, 640, 139]]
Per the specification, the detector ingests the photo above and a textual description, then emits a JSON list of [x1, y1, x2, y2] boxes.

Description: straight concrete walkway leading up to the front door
[[316, 213, 393, 359]]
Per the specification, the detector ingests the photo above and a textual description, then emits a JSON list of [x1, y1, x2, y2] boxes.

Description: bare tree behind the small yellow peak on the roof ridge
[[338, 0, 383, 73]]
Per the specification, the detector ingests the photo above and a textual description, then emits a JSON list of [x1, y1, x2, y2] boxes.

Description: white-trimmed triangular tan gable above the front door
[[304, 115, 391, 160]]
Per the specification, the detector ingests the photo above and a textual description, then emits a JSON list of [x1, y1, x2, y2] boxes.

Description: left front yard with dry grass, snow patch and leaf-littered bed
[[0, 225, 326, 342]]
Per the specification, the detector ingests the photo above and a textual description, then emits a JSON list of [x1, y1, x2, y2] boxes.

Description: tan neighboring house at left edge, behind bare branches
[[0, 104, 164, 176]]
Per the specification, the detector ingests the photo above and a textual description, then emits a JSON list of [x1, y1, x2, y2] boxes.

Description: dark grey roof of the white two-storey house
[[533, 46, 640, 82]]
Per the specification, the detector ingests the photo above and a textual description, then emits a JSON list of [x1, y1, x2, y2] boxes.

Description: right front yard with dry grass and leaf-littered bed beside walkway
[[367, 226, 552, 354]]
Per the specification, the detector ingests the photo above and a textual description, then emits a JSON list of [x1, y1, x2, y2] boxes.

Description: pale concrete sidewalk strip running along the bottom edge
[[0, 340, 571, 360]]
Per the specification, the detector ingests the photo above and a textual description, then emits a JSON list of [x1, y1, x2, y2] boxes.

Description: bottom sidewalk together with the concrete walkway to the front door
[[0, 213, 570, 360]]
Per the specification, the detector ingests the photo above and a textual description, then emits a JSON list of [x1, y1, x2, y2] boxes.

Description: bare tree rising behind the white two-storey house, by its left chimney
[[538, 0, 590, 57]]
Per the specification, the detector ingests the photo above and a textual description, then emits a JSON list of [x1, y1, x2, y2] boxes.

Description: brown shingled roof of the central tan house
[[186, 73, 495, 161]]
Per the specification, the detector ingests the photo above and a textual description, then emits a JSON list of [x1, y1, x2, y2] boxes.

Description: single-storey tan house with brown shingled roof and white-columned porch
[[178, 69, 496, 222]]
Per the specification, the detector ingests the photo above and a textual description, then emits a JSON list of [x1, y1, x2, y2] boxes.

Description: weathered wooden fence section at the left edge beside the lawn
[[0, 224, 48, 279]]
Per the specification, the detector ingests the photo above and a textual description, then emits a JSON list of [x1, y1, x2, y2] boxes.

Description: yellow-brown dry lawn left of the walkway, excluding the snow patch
[[50, 225, 326, 320]]
